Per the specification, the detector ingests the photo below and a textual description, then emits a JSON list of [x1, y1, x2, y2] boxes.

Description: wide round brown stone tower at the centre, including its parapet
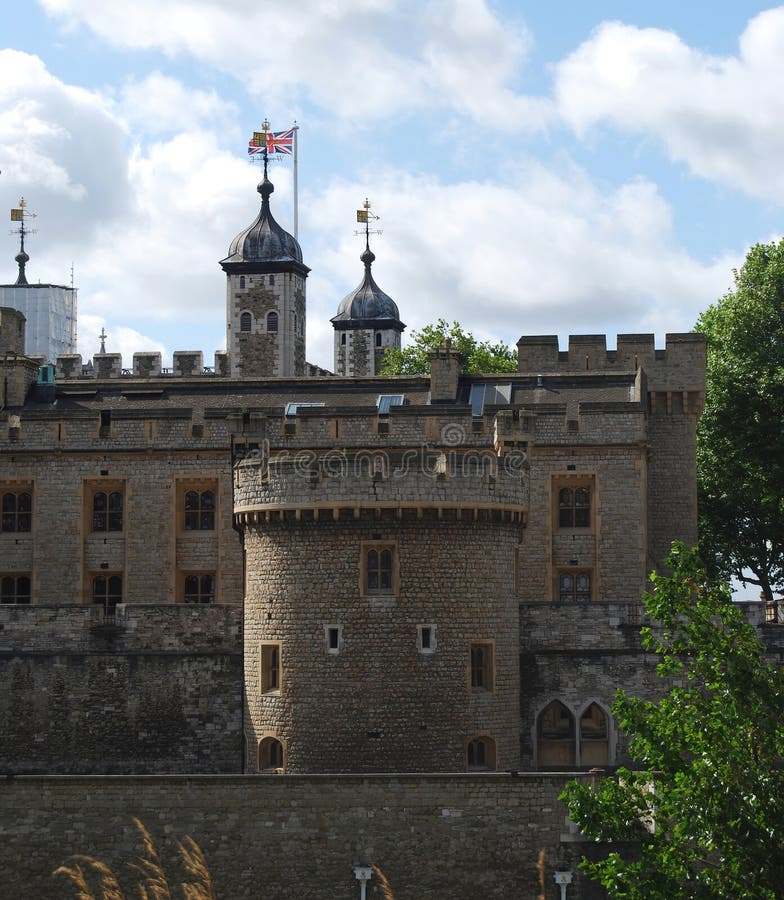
[[235, 436, 528, 773]]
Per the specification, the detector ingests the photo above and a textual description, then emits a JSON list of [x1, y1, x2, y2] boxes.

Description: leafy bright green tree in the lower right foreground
[[562, 544, 784, 900]]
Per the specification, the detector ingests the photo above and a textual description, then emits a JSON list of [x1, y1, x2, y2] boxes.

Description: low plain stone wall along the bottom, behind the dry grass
[[0, 774, 602, 900]]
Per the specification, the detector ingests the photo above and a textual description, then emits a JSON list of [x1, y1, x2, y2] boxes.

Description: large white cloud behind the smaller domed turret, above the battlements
[[306, 160, 740, 364]]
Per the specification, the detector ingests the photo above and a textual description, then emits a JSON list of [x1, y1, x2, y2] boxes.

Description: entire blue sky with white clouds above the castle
[[0, 0, 784, 368]]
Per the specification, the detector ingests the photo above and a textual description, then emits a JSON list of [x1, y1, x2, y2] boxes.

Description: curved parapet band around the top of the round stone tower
[[234, 449, 528, 525]]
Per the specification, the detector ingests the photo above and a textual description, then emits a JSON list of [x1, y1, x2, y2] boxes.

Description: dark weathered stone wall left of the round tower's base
[[0, 605, 242, 772]]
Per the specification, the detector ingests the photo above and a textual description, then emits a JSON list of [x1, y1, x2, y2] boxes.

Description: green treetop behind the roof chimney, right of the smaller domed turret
[[381, 319, 517, 375]]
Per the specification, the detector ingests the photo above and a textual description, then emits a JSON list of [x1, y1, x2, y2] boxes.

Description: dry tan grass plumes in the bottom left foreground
[[52, 819, 216, 900]]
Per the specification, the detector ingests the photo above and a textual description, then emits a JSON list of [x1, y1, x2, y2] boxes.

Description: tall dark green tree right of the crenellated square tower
[[697, 241, 784, 601]]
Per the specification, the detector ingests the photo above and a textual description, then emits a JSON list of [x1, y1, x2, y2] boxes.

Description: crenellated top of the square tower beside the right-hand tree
[[517, 332, 706, 390]]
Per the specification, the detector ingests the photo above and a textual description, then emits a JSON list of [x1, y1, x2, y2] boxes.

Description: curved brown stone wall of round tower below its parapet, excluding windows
[[245, 511, 519, 772]]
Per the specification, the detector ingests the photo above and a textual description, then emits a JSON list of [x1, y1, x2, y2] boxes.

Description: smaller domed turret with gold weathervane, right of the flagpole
[[332, 243, 406, 375]]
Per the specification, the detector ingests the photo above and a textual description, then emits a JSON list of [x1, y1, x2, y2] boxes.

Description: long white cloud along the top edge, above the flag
[[41, 0, 550, 129]]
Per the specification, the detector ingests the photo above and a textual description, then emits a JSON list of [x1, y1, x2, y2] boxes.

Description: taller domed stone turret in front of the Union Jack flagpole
[[220, 160, 310, 378]]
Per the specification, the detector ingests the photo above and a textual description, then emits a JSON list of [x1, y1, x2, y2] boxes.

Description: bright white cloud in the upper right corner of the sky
[[555, 7, 784, 203]]
